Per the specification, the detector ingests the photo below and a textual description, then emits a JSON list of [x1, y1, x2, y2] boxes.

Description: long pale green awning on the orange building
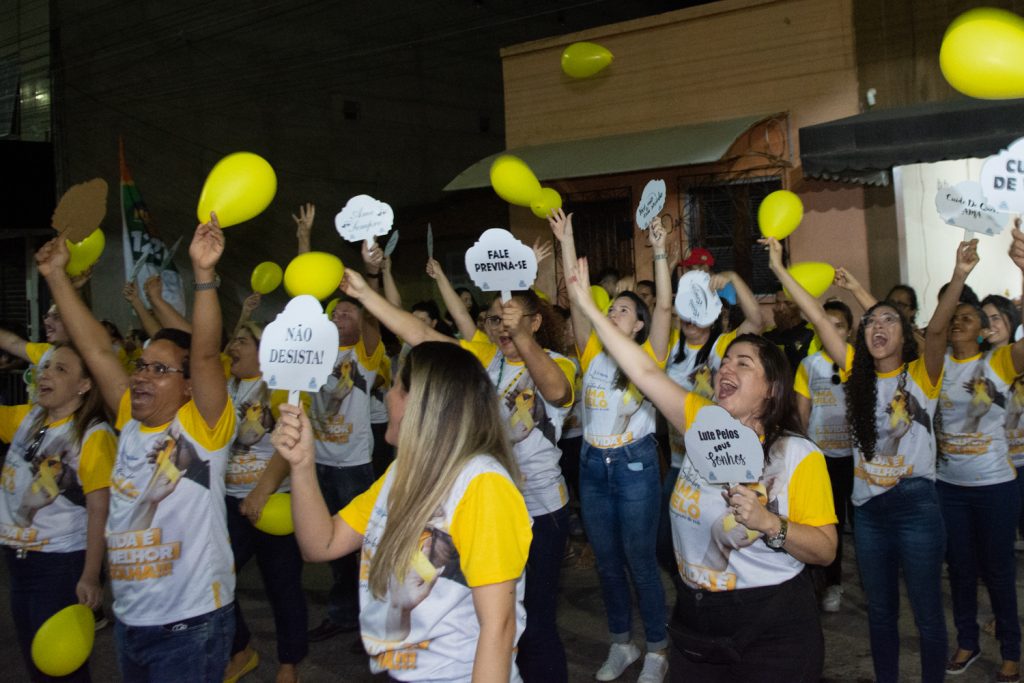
[[444, 115, 771, 190]]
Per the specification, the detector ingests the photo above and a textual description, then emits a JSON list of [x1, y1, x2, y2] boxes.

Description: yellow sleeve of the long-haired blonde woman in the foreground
[[450, 472, 534, 588]]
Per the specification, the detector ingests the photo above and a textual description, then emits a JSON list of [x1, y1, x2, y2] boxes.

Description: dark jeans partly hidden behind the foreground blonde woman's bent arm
[[316, 463, 374, 628]]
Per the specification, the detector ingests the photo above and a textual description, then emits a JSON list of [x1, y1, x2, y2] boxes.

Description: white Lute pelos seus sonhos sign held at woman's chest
[[683, 405, 765, 485]]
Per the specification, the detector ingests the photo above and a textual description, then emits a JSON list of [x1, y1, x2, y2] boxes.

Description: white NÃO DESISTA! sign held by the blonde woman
[[259, 294, 338, 395]]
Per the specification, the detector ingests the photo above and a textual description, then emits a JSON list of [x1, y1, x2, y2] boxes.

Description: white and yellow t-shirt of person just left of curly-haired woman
[[793, 344, 853, 458]]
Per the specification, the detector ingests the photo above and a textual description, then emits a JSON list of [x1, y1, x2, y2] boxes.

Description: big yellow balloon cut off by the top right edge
[[939, 7, 1024, 99]]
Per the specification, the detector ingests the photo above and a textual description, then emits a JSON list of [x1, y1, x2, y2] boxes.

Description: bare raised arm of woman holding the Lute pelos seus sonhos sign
[[566, 258, 689, 432]]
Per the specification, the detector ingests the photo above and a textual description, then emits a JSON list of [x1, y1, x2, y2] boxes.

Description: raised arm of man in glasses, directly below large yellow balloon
[[188, 213, 227, 427]]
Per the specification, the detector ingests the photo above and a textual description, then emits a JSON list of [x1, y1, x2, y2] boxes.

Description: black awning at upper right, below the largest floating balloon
[[800, 99, 1024, 185]]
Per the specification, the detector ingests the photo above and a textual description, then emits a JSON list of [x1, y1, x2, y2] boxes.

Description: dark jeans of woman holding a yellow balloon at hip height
[[230, 496, 309, 664]]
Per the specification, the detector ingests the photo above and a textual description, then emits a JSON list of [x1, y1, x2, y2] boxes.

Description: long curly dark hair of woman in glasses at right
[[845, 301, 918, 460]]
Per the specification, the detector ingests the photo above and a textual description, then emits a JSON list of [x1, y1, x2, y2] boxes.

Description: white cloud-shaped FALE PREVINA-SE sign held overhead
[[466, 227, 537, 301]]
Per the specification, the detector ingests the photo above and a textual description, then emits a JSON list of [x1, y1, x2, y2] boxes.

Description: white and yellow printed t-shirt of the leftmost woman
[[0, 405, 118, 553]]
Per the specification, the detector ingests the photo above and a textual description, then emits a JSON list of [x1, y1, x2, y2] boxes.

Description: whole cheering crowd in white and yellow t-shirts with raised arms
[[0, 206, 1024, 683]]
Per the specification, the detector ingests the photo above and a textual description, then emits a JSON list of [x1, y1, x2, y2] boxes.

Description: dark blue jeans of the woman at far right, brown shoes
[[935, 481, 1021, 661]]
